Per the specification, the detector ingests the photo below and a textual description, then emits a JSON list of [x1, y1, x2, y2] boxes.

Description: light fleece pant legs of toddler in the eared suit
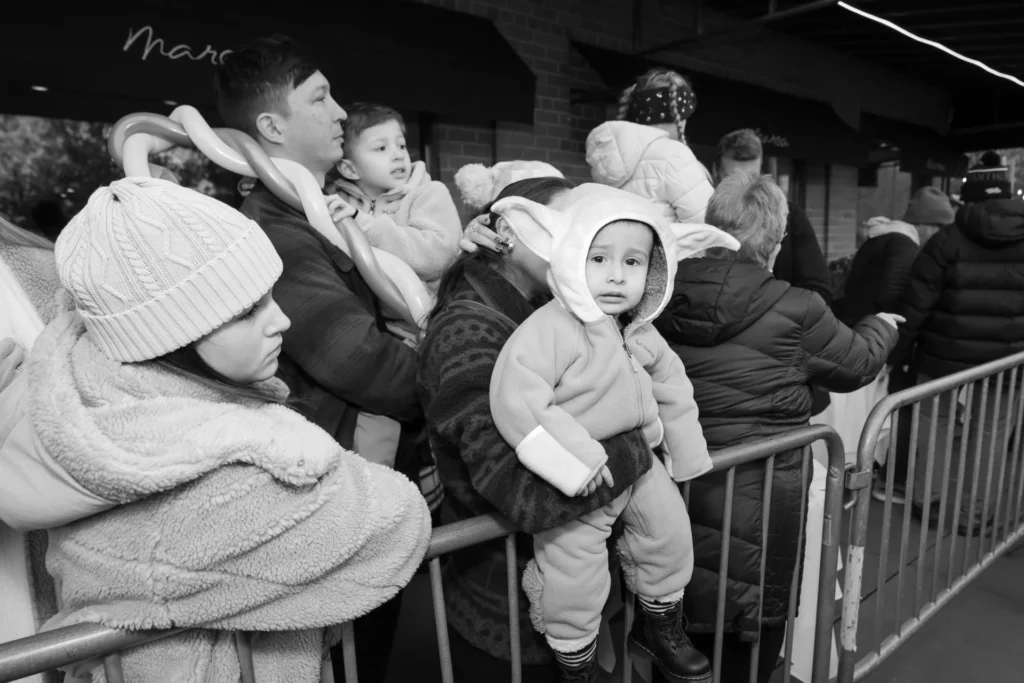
[[534, 457, 693, 652]]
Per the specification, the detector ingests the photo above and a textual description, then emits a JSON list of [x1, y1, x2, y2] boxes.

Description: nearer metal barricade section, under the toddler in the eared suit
[[0, 425, 845, 683]]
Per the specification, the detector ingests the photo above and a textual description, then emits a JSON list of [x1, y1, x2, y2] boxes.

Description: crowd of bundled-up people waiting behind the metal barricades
[[0, 31, 1024, 683]]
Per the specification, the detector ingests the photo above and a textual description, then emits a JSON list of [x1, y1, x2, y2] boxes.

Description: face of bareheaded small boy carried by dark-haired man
[[340, 119, 412, 199]]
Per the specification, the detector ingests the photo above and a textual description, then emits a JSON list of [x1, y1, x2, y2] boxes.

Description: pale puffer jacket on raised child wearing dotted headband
[[587, 121, 715, 223]]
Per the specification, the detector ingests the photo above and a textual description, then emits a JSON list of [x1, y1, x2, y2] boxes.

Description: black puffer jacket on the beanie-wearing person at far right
[[893, 200, 1024, 377]]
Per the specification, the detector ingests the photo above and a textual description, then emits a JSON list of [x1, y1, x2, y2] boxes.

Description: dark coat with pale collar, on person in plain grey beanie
[[833, 216, 921, 325]]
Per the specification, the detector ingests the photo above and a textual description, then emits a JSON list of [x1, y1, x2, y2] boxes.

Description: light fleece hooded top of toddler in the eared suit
[[490, 188, 712, 496]]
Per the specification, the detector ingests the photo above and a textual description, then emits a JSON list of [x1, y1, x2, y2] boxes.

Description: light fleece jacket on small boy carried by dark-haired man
[[327, 161, 462, 291]]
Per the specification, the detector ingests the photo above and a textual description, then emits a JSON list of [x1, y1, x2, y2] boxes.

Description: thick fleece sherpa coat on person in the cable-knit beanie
[[18, 312, 430, 683]]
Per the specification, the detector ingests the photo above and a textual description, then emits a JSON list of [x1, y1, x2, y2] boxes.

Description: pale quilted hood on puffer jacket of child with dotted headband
[[587, 121, 669, 187]]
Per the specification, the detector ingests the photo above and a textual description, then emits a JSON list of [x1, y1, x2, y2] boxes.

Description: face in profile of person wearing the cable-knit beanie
[[196, 292, 292, 384]]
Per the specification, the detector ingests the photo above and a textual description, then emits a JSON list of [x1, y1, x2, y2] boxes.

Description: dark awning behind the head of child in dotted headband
[[572, 41, 870, 166]]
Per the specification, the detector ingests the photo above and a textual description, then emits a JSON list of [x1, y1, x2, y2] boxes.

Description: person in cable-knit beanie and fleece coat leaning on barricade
[[0, 177, 430, 683]]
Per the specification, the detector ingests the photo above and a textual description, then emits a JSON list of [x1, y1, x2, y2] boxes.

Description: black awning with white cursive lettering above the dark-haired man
[[0, 0, 536, 124]]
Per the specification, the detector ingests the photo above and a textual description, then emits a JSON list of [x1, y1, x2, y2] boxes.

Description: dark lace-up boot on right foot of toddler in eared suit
[[630, 600, 711, 683]]
